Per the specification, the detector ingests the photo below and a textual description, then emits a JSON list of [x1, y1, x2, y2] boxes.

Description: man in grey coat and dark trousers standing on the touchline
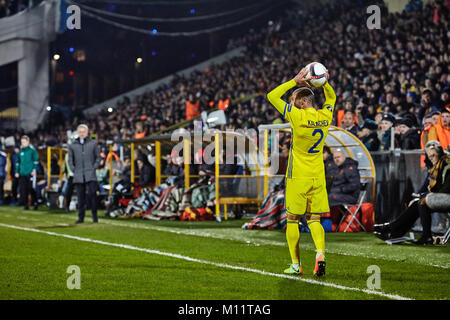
[[68, 124, 100, 223]]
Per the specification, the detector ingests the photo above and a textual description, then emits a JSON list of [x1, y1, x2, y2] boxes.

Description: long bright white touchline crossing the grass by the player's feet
[[0, 223, 413, 300]]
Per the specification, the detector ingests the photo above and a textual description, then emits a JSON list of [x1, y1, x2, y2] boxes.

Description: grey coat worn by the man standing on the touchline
[[68, 137, 100, 183]]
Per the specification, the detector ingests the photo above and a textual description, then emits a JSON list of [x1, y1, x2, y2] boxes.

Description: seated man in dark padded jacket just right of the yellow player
[[328, 149, 361, 207]]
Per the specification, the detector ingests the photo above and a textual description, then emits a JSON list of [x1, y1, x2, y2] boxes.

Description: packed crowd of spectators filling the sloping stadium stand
[[3, 0, 450, 155]]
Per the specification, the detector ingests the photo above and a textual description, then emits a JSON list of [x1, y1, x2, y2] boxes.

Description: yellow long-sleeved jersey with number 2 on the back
[[267, 79, 336, 179]]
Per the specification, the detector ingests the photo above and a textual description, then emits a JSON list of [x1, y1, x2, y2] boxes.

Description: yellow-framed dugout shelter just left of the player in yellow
[[115, 130, 268, 220]]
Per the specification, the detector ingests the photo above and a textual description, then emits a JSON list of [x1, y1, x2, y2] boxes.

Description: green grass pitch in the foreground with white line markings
[[0, 206, 450, 300]]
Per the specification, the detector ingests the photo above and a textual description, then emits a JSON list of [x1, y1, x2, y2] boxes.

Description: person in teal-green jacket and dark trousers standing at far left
[[15, 136, 39, 210]]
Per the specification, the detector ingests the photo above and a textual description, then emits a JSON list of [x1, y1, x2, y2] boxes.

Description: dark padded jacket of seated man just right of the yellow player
[[330, 158, 361, 200]]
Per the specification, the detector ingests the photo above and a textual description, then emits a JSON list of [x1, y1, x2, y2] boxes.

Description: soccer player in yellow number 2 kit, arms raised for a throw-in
[[267, 68, 336, 277]]
